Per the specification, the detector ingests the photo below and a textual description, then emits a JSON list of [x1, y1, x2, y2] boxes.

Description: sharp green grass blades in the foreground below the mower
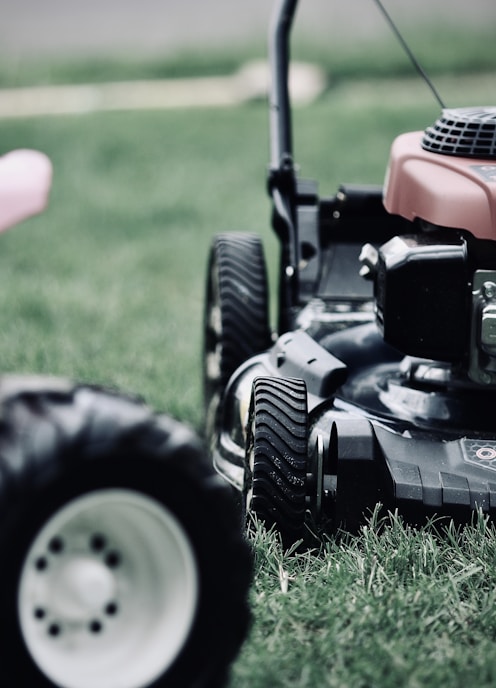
[[231, 515, 496, 688]]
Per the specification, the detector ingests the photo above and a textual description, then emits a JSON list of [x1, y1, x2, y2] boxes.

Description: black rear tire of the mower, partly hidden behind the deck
[[203, 233, 272, 436]]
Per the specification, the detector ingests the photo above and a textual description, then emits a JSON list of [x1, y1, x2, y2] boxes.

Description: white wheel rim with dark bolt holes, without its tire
[[18, 489, 198, 688]]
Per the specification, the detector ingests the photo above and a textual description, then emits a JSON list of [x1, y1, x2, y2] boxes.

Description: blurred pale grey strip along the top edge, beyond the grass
[[0, 0, 496, 59]]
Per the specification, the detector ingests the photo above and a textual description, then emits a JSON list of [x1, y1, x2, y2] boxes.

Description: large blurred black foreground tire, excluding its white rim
[[0, 377, 252, 688]]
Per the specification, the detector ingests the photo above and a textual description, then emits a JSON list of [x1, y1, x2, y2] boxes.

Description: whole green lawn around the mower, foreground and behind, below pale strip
[[0, 32, 496, 688]]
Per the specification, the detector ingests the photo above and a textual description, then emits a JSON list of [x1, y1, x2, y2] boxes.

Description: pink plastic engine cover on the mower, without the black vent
[[384, 131, 496, 239]]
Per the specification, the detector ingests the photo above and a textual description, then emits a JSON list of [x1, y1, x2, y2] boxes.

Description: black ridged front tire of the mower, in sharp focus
[[244, 377, 308, 547]]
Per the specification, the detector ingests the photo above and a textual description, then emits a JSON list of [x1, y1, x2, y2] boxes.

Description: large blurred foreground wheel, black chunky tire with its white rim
[[0, 378, 251, 688]]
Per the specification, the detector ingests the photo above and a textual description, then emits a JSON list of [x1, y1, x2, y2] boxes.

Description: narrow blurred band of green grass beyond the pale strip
[[0, 20, 496, 88]]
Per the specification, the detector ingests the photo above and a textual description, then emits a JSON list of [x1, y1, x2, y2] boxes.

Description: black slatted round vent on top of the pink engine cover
[[422, 107, 496, 160]]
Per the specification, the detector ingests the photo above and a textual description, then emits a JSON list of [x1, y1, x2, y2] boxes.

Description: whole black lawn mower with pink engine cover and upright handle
[[204, 0, 496, 545]]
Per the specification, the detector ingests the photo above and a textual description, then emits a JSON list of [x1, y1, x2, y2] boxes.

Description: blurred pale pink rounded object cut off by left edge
[[0, 150, 52, 232]]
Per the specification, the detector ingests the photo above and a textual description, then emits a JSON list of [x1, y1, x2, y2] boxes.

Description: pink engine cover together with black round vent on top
[[384, 108, 496, 239]]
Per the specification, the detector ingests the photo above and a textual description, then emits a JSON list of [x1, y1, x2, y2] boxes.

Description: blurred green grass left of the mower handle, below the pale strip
[[0, 103, 268, 425]]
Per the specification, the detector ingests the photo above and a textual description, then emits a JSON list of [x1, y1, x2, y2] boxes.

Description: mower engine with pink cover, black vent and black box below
[[372, 108, 496, 387]]
